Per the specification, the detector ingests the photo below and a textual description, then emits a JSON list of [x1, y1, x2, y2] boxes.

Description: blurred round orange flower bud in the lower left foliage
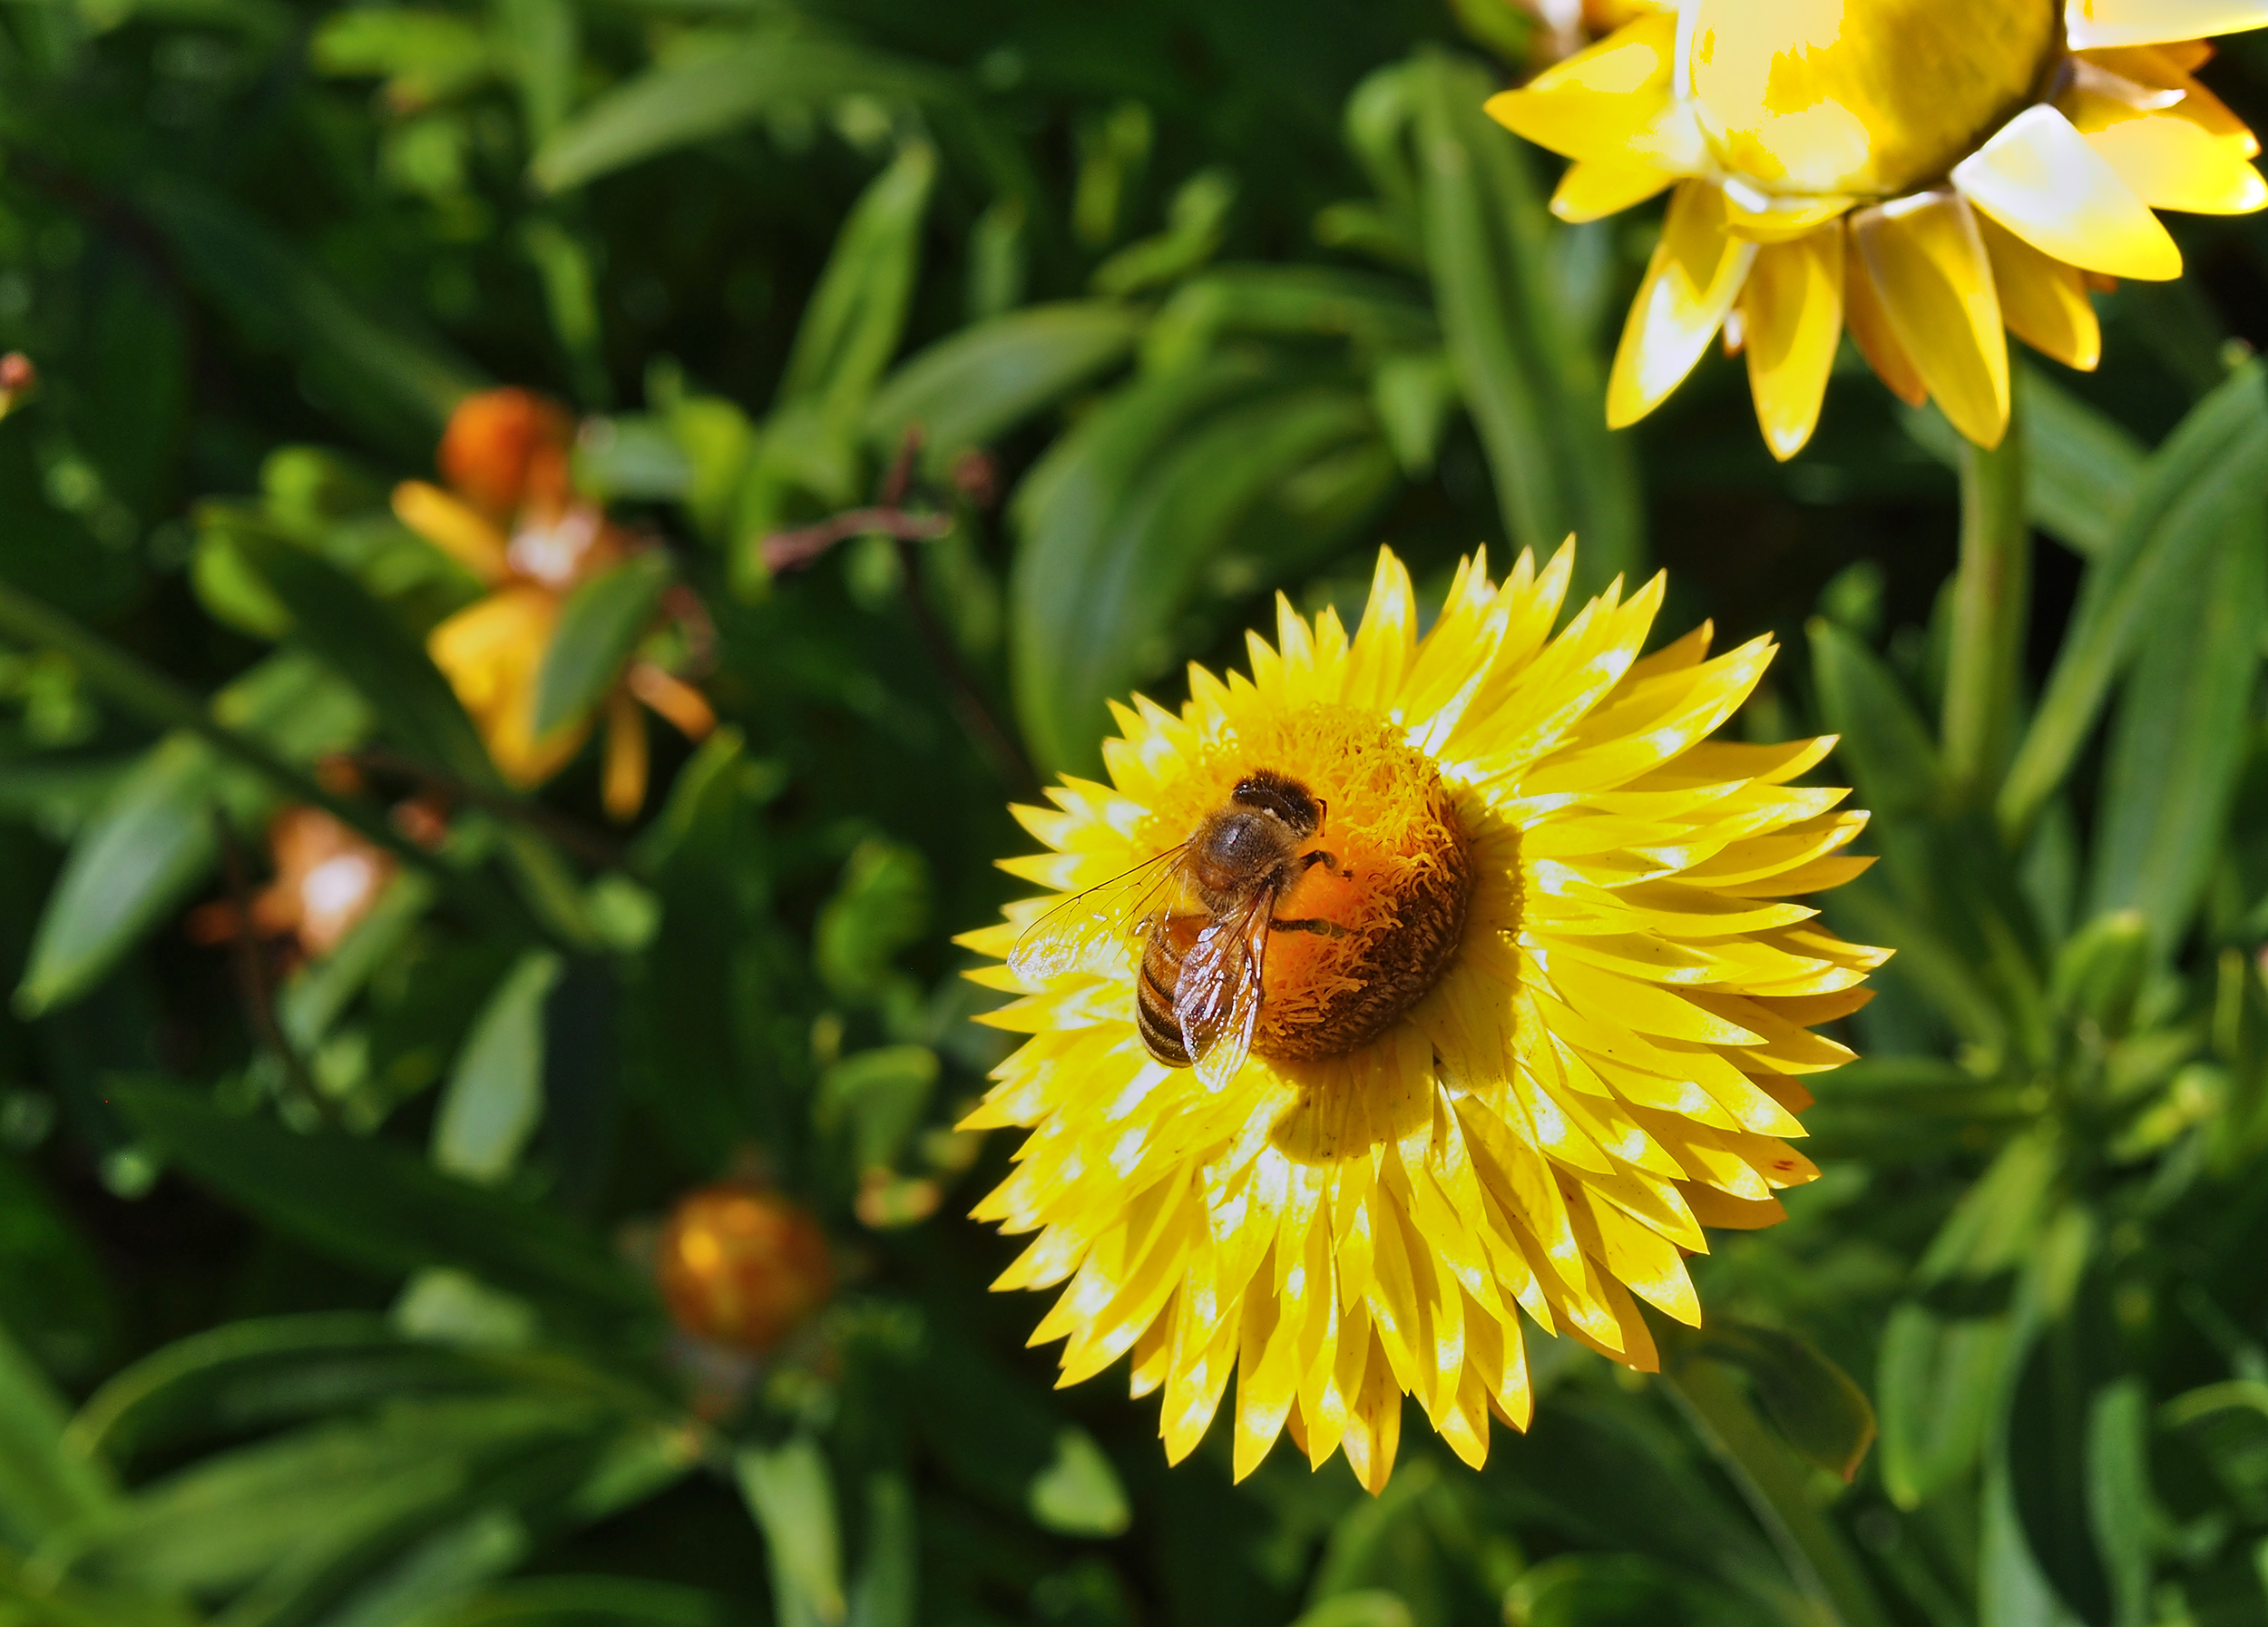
[[658, 1182, 835, 1352]]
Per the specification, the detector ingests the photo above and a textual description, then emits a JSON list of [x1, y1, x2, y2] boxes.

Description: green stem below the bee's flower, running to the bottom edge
[[1663, 1352, 1890, 1627]]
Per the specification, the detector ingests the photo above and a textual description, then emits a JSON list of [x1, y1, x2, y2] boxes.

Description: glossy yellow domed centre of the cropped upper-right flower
[[1692, 0, 2062, 198]]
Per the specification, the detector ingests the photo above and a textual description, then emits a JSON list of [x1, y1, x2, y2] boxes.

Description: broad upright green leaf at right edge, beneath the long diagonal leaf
[[2089, 495, 2268, 956]]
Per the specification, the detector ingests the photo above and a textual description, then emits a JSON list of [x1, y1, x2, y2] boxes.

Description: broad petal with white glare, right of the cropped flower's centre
[[1953, 107, 2182, 281]]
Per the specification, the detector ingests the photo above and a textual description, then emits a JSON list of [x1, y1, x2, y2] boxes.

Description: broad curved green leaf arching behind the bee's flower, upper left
[[1010, 357, 1377, 771]]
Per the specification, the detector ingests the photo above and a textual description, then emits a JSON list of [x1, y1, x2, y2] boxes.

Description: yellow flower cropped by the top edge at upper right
[[1488, 0, 2268, 458]]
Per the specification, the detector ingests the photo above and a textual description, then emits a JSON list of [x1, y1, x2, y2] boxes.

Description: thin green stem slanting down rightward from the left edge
[[0, 581, 533, 935]]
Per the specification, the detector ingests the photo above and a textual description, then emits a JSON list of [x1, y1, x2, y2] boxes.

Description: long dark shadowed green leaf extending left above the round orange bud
[[113, 1080, 653, 1320]]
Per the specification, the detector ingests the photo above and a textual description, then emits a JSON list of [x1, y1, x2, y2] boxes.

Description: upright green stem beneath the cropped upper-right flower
[[1944, 411, 2032, 806]]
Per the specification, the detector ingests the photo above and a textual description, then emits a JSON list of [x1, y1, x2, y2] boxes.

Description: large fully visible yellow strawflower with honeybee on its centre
[[962, 544, 1882, 1491]]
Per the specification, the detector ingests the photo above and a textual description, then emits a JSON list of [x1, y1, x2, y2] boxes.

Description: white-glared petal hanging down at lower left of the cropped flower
[[1606, 181, 1755, 429]]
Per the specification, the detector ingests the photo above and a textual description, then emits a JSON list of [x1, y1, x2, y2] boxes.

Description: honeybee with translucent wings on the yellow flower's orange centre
[[1007, 769, 1343, 1087]]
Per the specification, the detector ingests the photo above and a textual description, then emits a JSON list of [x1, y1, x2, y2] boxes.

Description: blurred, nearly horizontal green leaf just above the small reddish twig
[[866, 299, 1143, 470]]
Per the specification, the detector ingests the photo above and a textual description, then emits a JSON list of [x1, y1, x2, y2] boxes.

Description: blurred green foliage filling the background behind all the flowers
[[0, 0, 2268, 1627]]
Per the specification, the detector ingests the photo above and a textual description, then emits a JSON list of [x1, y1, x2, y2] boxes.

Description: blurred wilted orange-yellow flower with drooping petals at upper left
[[395, 390, 717, 819]]
